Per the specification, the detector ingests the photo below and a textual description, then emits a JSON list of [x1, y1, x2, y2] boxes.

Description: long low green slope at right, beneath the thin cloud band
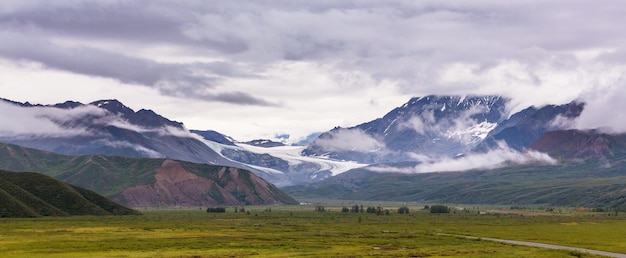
[[283, 153, 626, 207]]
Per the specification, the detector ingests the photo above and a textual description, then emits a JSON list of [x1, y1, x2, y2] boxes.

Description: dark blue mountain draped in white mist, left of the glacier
[[0, 100, 243, 167]]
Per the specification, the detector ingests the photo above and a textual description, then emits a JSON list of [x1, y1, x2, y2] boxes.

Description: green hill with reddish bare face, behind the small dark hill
[[0, 143, 298, 206]]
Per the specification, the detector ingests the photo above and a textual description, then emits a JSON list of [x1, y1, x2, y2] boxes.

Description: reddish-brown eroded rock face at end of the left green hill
[[111, 160, 288, 207]]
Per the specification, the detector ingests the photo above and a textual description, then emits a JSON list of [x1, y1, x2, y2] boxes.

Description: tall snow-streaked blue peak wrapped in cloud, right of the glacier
[[303, 96, 508, 163]]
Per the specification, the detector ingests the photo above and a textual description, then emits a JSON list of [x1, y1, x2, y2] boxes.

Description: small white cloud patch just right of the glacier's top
[[315, 128, 385, 152]]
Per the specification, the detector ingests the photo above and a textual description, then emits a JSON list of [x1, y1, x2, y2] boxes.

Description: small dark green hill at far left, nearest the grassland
[[0, 170, 139, 217]]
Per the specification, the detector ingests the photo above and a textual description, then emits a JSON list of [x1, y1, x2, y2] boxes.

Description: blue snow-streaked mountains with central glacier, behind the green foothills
[[0, 96, 583, 186]]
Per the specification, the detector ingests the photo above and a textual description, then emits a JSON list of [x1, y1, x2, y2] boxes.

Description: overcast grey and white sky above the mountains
[[0, 0, 626, 142]]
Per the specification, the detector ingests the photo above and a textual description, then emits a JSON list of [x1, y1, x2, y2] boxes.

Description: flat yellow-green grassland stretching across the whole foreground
[[0, 206, 626, 257]]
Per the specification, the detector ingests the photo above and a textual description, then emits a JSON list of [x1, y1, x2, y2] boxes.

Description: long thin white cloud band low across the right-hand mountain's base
[[368, 143, 557, 173]]
